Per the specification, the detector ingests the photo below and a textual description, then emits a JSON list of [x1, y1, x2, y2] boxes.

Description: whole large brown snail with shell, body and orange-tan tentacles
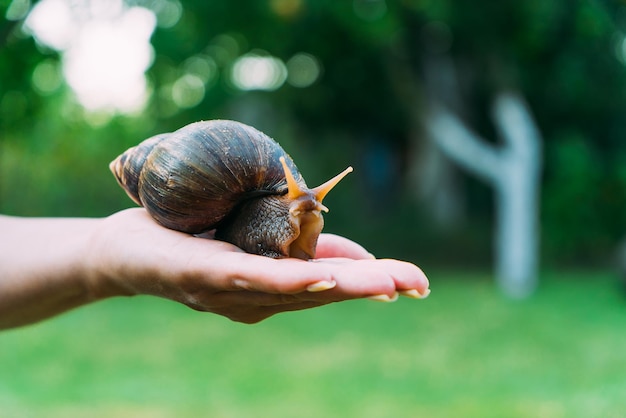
[[110, 120, 352, 260]]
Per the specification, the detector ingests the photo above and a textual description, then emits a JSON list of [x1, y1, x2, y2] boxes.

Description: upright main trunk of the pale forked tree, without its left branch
[[493, 93, 541, 297]]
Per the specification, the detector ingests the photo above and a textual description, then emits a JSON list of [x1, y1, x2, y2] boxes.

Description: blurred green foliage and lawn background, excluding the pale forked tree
[[0, 0, 626, 417]]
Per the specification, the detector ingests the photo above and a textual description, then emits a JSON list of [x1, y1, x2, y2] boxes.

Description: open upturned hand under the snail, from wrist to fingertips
[[87, 208, 429, 323]]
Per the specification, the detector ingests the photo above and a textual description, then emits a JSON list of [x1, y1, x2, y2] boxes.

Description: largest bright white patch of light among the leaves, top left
[[25, 0, 156, 113]]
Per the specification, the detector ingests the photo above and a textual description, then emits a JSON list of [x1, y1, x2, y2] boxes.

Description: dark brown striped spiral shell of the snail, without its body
[[111, 120, 306, 233]]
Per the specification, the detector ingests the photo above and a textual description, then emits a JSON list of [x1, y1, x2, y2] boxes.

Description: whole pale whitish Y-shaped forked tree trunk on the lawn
[[424, 93, 541, 298]]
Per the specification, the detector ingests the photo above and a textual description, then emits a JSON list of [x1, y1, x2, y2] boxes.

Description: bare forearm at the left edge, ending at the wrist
[[0, 216, 97, 329]]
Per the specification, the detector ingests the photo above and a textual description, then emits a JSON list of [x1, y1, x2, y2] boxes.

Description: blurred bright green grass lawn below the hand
[[0, 272, 626, 418]]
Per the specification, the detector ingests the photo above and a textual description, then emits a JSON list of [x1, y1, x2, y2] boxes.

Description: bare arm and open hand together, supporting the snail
[[0, 208, 430, 329]]
